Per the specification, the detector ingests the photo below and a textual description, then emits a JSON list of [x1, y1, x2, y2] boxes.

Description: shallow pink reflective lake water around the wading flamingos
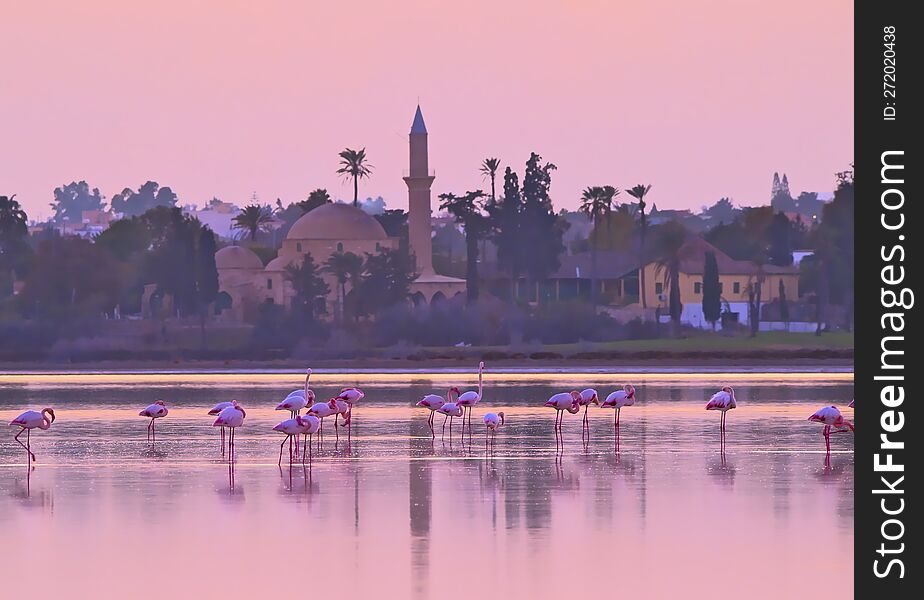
[[0, 372, 854, 598]]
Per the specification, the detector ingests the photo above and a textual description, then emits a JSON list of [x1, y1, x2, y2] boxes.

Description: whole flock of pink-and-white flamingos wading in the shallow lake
[[10, 361, 855, 464]]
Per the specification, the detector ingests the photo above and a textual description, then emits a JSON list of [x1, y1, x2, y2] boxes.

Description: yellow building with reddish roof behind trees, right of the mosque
[[644, 237, 799, 327]]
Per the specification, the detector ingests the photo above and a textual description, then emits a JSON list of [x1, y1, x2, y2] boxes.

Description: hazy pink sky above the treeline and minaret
[[0, 0, 853, 216]]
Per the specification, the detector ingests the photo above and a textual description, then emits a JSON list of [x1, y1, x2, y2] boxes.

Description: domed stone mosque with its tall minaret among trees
[[215, 106, 465, 320]]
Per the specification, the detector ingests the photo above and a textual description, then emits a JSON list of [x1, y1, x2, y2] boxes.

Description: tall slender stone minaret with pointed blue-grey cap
[[404, 106, 434, 275]]
